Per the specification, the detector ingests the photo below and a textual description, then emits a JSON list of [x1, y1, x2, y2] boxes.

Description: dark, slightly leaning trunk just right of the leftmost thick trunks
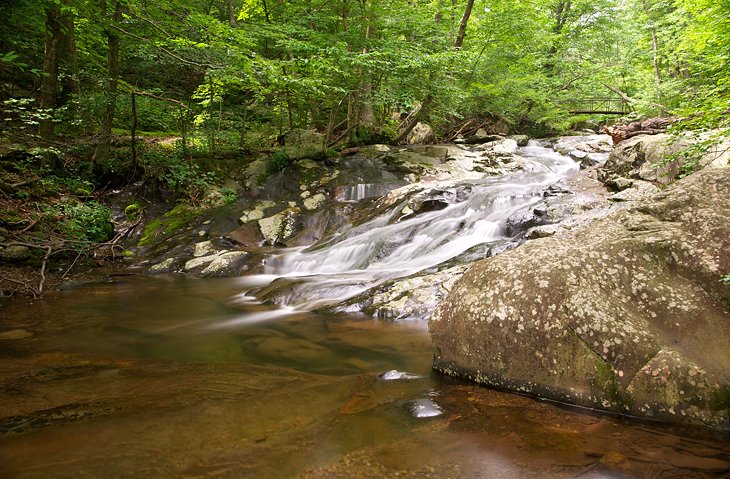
[[92, 0, 122, 164]]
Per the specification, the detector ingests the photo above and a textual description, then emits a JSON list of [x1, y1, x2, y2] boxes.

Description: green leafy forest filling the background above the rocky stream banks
[[0, 0, 730, 150]]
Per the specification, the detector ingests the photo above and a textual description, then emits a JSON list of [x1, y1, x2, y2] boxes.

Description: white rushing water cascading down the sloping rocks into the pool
[[242, 141, 578, 310]]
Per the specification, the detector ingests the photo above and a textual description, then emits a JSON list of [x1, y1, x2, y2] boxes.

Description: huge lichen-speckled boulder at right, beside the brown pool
[[429, 168, 730, 429]]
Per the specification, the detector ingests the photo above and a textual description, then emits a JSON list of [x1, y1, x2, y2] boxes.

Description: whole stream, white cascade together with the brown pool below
[[0, 139, 730, 478]]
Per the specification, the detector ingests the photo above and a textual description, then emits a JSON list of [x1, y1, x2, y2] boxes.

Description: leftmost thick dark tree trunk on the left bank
[[39, 3, 61, 140]]
